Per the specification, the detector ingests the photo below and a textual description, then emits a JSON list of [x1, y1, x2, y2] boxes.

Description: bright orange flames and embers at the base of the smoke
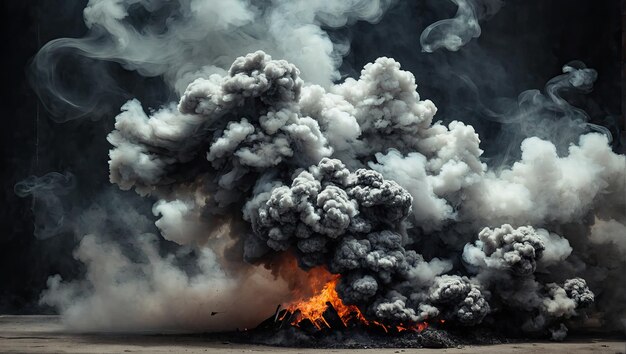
[[281, 267, 428, 332]]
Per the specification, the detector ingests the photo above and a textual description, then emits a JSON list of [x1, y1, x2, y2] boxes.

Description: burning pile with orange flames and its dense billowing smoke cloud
[[22, 0, 626, 346]]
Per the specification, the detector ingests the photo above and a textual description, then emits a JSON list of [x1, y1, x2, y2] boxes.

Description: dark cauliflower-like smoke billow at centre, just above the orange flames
[[244, 158, 412, 267]]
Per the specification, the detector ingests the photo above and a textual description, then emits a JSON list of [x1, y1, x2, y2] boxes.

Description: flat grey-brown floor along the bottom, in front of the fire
[[0, 316, 626, 354]]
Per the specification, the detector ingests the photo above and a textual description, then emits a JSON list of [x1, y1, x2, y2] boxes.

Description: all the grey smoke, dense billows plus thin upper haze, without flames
[[26, 0, 626, 338]]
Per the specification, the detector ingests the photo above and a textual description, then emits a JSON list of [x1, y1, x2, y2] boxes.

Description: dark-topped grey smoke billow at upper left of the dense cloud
[[108, 52, 330, 193]]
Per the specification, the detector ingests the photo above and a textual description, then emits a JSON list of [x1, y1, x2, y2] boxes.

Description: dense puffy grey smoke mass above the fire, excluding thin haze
[[35, 52, 625, 331]]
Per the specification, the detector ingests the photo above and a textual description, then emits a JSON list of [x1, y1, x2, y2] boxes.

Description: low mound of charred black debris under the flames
[[212, 303, 509, 348]]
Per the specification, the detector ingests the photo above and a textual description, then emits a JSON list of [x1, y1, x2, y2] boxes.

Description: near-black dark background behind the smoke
[[0, 0, 624, 314]]
